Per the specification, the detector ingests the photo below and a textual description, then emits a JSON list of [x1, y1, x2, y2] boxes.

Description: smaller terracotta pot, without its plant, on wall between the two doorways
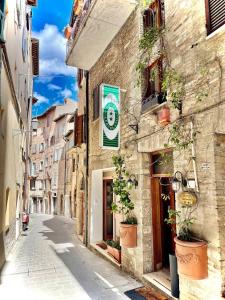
[[120, 223, 137, 248]]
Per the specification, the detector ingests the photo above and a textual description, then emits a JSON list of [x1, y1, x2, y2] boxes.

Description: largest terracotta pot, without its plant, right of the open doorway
[[174, 237, 208, 280]]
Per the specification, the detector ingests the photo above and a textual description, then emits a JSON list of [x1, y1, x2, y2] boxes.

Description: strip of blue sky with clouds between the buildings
[[32, 0, 77, 116]]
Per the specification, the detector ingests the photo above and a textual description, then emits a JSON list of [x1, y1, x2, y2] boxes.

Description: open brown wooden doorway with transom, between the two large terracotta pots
[[151, 152, 175, 271]]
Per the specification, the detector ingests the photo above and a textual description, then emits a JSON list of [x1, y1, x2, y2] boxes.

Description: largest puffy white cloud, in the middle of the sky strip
[[33, 24, 76, 82]]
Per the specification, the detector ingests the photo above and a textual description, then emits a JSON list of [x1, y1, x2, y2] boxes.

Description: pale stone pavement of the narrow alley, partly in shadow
[[0, 215, 141, 300]]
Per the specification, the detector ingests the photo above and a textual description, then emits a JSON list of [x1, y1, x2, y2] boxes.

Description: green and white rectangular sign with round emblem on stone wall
[[100, 84, 120, 150]]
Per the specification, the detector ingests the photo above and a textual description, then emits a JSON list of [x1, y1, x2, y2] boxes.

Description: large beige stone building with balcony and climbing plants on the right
[[67, 0, 225, 300]]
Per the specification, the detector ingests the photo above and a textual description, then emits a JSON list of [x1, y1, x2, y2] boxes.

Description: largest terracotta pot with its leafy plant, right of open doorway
[[165, 206, 208, 280]]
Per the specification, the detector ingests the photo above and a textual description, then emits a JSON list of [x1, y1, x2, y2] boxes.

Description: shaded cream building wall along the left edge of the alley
[[0, 0, 39, 268]]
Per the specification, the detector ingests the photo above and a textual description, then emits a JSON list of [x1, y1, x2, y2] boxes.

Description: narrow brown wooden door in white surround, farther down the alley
[[103, 179, 113, 241]]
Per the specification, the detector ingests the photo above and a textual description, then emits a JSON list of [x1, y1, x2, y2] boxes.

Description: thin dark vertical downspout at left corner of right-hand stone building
[[85, 71, 89, 247]]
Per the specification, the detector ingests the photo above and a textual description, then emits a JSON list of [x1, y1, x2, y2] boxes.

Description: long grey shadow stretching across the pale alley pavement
[[40, 217, 124, 299]]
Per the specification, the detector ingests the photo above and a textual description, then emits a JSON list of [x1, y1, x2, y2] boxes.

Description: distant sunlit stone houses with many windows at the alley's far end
[[30, 99, 76, 214]]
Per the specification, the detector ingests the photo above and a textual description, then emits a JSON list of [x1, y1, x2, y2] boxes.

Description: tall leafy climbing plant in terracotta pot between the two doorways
[[112, 155, 137, 248]]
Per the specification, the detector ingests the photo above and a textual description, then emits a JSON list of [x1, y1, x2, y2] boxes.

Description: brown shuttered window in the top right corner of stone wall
[[205, 0, 225, 34]]
